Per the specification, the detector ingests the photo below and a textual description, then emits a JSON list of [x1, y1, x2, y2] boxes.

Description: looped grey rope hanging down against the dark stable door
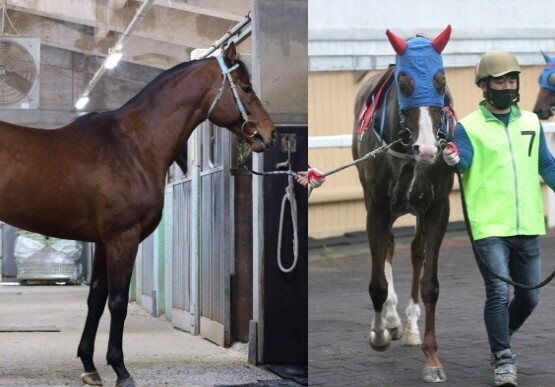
[[277, 141, 299, 273]]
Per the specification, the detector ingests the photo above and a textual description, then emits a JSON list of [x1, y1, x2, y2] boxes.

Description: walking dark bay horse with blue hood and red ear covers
[[352, 26, 454, 382]]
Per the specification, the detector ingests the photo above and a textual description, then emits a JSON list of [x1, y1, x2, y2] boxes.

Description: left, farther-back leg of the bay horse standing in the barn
[[77, 243, 108, 386]]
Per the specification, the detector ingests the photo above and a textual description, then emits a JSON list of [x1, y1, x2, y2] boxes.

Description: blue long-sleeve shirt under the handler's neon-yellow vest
[[453, 113, 555, 191]]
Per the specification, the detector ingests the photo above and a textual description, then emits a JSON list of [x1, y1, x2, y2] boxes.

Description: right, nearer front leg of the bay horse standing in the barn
[[105, 227, 140, 387]]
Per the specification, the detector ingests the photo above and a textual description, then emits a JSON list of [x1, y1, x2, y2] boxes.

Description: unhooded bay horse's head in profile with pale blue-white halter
[[208, 43, 276, 152]]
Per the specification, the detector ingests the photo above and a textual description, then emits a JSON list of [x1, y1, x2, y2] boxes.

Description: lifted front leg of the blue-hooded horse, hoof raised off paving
[[366, 205, 398, 351]]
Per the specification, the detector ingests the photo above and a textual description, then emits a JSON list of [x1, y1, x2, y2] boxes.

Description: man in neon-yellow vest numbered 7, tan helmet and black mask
[[443, 50, 555, 386]]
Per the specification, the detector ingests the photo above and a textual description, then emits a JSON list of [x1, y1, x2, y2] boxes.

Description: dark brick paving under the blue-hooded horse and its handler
[[309, 226, 555, 387]]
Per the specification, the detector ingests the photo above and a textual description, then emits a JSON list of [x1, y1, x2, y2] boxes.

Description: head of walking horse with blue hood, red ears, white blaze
[[386, 26, 451, 164]]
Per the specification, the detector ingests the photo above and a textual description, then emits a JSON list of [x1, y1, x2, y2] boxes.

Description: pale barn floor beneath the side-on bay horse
[[0, 285, 286, 387]]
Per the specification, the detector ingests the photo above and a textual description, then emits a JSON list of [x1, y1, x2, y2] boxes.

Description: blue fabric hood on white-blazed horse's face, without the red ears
[[395, 37, 445, 109]]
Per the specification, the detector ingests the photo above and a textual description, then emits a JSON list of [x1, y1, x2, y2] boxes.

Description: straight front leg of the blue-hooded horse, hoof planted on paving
[[420, 205, 449, 382]]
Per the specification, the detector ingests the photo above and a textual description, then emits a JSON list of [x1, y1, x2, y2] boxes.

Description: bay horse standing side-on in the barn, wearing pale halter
[[0, 43, 276, 387]]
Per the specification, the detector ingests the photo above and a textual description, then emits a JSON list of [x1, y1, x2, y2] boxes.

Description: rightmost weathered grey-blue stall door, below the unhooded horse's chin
[[199, 124, 233, 346]]
